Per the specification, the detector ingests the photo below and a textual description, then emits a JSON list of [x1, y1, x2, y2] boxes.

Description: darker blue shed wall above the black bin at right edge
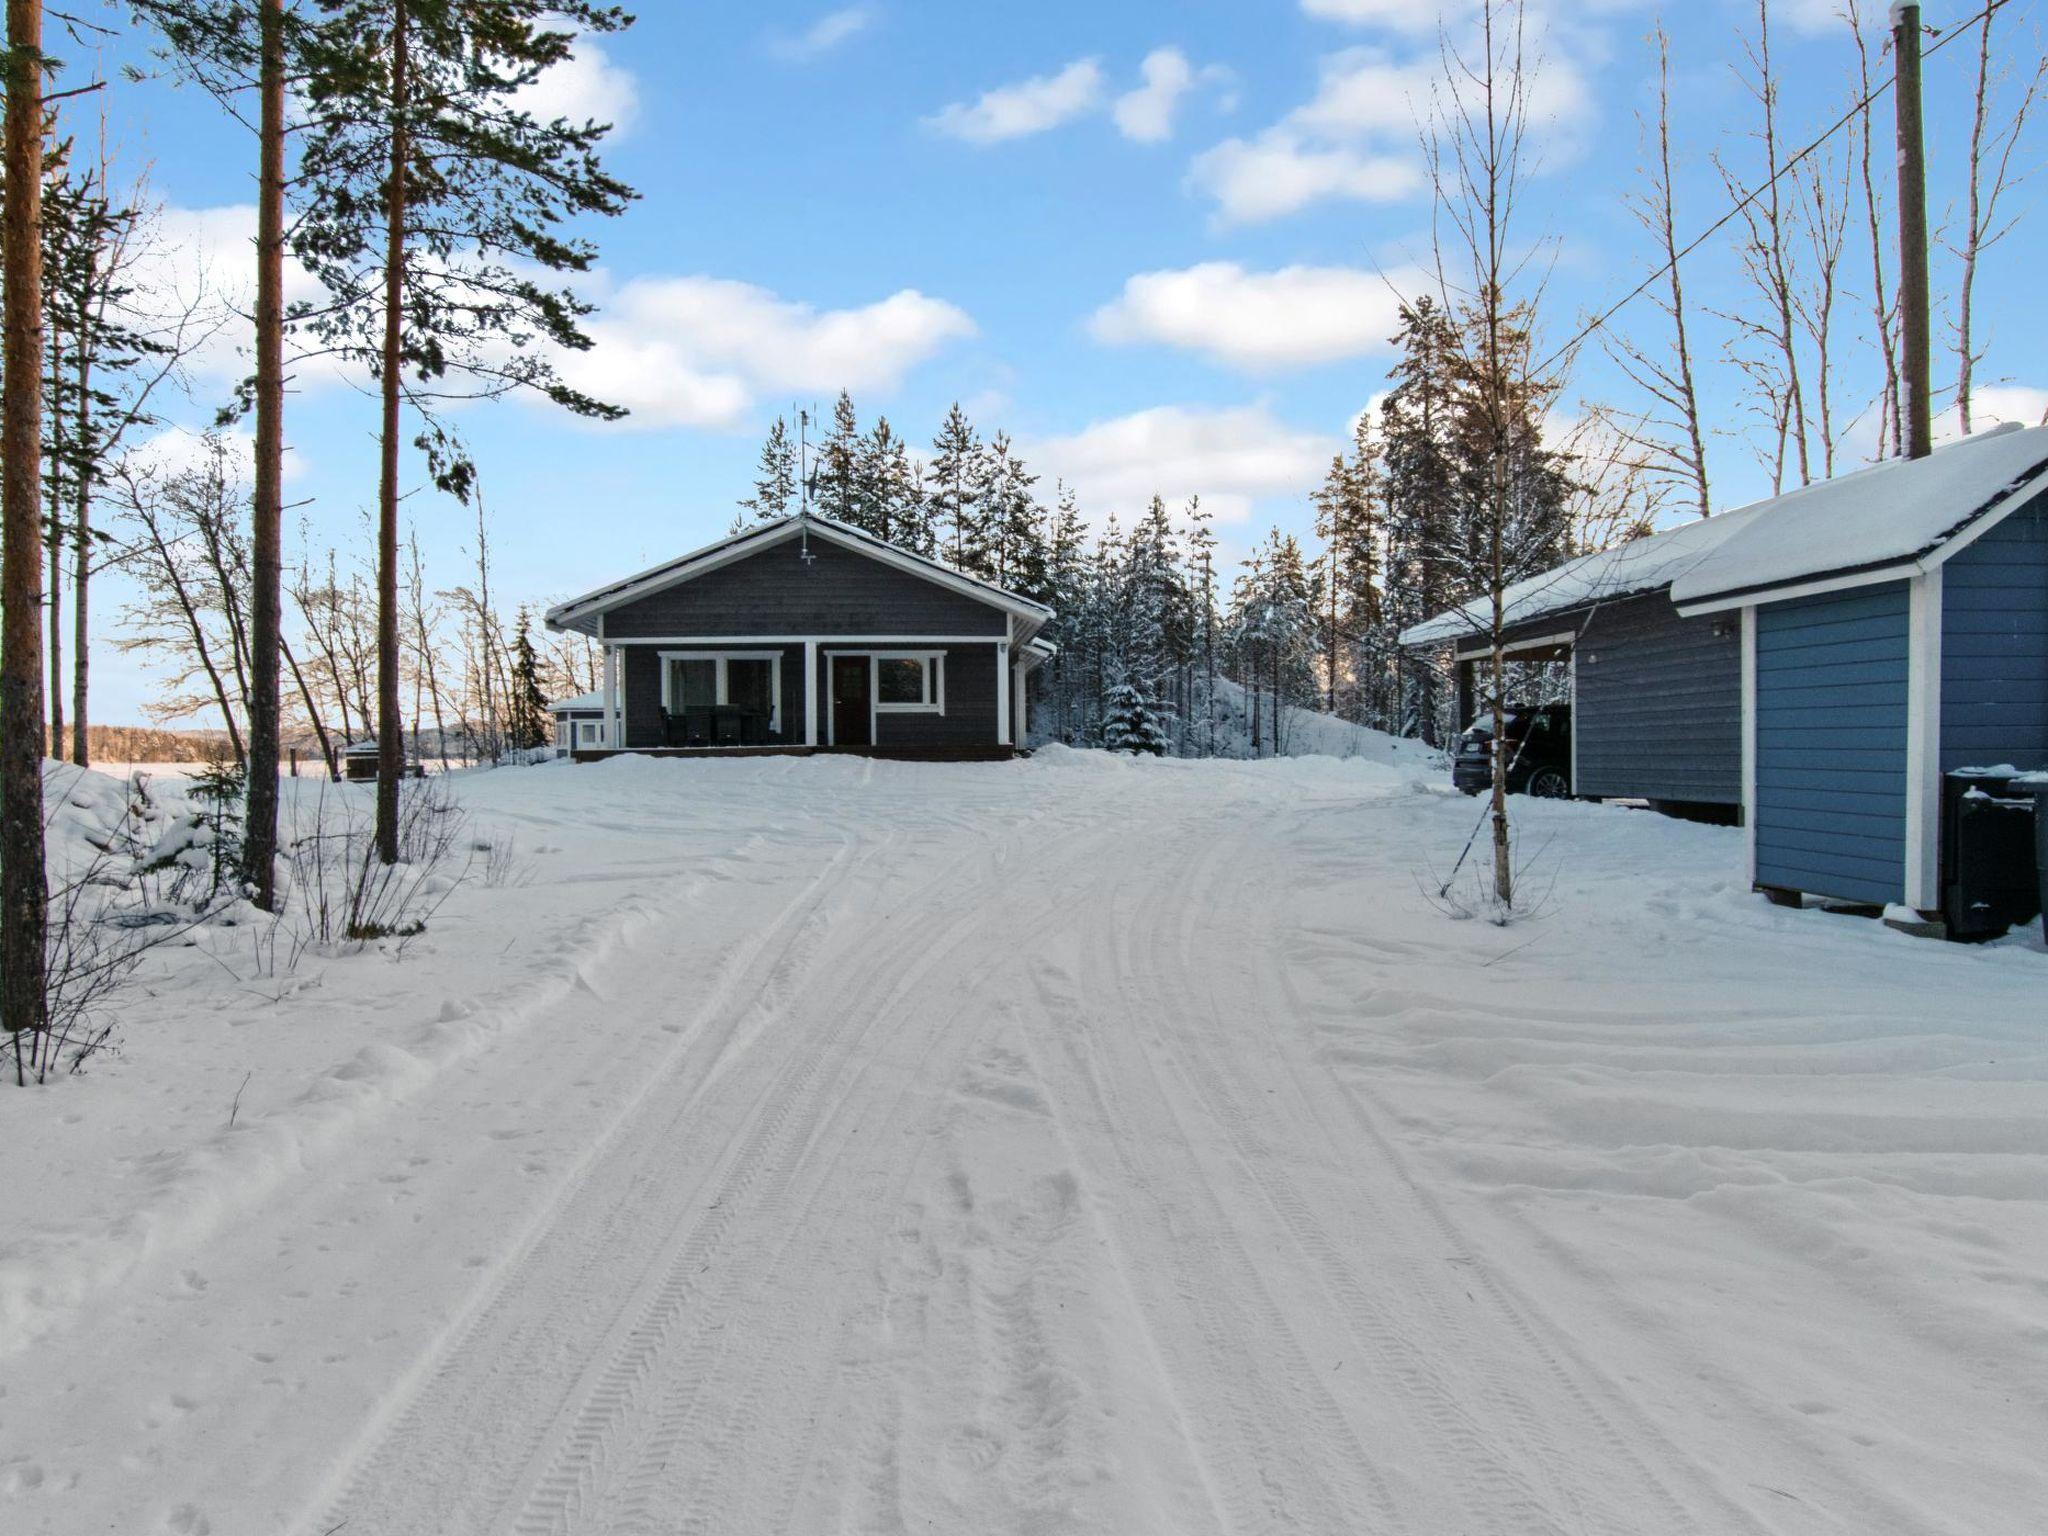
[[1942, 498, 2048, 772]]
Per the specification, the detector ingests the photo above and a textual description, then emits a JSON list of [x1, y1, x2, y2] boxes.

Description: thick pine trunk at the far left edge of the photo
[[0, 0, 49, 1056]]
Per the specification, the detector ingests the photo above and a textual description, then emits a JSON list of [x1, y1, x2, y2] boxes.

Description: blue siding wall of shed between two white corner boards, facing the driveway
[[1755, 582, 1911, 903]]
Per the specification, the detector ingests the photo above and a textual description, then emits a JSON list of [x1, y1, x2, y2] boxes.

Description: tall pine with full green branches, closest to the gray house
[[295, 0, 633, 864]]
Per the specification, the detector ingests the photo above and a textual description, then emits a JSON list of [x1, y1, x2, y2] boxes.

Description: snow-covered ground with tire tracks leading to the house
[[0, 750, 2048, 1536]]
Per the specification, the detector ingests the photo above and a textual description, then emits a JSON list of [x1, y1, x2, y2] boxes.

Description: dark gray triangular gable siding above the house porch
[[604, 539, 1010, 639]]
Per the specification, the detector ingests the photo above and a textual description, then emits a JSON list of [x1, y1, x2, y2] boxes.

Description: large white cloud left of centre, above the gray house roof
[[559, 276, 975, 430]]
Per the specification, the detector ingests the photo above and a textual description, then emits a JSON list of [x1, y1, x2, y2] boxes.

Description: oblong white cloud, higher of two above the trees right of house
[[1090, 262, 1425, 371]]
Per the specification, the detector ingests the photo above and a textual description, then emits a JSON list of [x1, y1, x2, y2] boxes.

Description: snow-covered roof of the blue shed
[[1671, 426, 2048, 614]]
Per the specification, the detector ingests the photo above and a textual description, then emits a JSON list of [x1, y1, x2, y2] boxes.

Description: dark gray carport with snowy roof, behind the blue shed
[[1401, 508, 1755, 813]]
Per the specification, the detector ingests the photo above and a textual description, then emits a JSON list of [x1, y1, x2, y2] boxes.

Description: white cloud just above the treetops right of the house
[[1020, 406, 1343, 524]]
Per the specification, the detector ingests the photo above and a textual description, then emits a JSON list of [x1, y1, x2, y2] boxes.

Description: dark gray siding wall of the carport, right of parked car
[[1573, 592, 1743, 805]]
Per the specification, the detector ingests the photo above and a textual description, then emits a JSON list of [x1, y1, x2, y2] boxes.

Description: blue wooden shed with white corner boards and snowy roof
[[1671, 426, 2048, 915]]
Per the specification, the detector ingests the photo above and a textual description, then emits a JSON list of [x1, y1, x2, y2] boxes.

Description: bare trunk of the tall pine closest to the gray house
[[377, 0, 410, 864]]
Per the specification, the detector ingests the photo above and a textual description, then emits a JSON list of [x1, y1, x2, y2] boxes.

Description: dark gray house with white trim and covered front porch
[[547, 514, 1053, 758]]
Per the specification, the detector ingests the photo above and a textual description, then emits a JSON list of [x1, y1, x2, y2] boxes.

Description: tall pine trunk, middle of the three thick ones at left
[[242, 0, 285, 911]]
